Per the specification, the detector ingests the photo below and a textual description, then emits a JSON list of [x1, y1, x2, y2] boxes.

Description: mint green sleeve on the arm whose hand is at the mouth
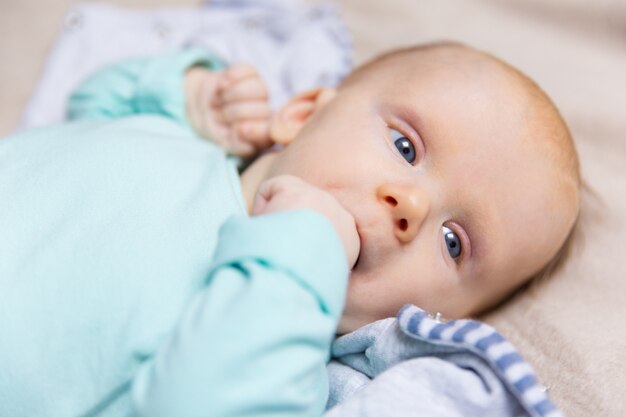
[[133, 211, 349, 417]]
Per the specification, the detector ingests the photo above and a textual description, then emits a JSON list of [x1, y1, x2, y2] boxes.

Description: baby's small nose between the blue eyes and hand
[[377, 184, 430, 243]]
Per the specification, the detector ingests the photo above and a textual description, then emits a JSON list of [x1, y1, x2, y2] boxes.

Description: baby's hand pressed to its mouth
[[252, 175, 361, 268]]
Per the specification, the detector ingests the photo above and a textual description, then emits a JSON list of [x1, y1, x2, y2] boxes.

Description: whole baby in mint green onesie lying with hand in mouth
[[0, 43, 579, 417]]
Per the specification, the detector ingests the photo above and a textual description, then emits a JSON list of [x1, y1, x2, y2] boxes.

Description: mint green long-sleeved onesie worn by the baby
[[0, 50, 348, 417]]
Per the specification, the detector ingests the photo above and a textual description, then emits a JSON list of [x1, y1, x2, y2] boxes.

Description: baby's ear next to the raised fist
[[270, 87, 337, 145]]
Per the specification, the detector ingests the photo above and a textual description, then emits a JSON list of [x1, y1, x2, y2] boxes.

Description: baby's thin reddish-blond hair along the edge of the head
[[339, 41, 583, 309]]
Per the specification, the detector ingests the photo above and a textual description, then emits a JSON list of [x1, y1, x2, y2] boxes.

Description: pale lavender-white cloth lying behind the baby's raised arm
[[19, 0, 352, 129]]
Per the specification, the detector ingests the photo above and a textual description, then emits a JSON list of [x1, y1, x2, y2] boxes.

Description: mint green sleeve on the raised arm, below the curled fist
[[67, 49, 223, 124]]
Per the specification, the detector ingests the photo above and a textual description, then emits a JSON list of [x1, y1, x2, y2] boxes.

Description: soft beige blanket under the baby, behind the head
[[0, 0, 626, 417]]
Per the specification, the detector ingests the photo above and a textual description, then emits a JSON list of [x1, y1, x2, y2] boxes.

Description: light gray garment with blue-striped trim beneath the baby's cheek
[[325, 306, 562, 417]]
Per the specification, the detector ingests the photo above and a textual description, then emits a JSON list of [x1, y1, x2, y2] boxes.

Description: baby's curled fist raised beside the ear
[[185, 64, 272, 158]]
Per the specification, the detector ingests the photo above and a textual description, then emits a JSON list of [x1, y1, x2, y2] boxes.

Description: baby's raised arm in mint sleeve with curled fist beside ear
[[67, 49, 272, 157]]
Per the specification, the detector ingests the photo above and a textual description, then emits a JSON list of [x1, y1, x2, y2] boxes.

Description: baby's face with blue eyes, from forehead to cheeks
[[272, 52, 575, 332]]
